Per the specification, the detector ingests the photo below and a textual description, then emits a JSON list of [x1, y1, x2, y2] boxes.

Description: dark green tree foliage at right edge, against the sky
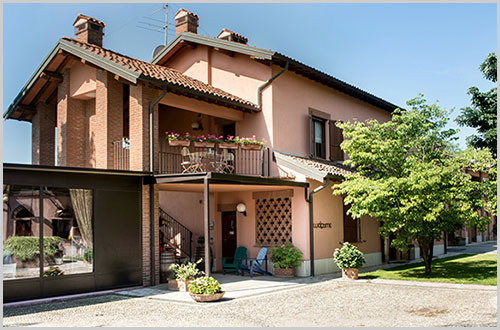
[[456, 53, 497, 158]]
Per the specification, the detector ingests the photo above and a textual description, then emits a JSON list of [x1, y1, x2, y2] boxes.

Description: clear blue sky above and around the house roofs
[[3, 3, 497, 163]]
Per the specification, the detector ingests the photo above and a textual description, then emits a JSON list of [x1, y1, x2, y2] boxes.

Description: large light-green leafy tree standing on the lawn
[[333, 95, 496, 274]]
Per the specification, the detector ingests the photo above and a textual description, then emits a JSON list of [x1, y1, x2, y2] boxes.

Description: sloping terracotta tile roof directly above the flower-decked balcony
[[62, 37, 258, 110]]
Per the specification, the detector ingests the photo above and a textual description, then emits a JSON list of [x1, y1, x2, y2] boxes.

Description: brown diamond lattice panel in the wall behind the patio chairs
[[255, 197, 292, 245]]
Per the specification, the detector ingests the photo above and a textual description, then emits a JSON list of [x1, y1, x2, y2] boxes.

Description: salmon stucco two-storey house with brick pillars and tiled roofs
[[4, 9, 488, 300]]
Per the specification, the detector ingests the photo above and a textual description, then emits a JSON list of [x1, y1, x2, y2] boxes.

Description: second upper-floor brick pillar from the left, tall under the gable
[[57, 70, 86, 167]]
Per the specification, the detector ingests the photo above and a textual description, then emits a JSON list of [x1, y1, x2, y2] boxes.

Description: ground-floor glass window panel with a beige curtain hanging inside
[[43, 187, 93, 277]]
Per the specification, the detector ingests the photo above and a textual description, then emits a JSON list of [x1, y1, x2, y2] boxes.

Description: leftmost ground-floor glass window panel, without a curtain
[[3, 184, 40, 281]]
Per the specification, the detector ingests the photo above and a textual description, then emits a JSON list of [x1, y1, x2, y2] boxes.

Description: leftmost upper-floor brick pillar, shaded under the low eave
[[31, 102, 56, 165]]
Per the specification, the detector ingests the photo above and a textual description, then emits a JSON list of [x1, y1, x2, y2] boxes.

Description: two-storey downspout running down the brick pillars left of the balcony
[[149, 86, 167, 285]]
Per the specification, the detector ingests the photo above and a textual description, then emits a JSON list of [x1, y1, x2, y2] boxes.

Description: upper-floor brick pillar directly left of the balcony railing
[[130, 84, 160, 171]]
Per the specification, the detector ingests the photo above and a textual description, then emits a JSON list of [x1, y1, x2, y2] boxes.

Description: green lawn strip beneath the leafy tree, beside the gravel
[[359, 254, 497, 285]]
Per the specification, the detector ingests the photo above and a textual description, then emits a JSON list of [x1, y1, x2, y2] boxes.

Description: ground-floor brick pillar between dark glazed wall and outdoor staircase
[[142, 185, 160, 286]]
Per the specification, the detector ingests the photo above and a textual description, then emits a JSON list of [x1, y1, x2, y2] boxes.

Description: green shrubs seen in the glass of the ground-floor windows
[[4, 236, 61, 261]]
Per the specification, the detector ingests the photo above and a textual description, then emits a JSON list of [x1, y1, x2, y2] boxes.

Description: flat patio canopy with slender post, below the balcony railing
[[145, 172, 312, 276]]
